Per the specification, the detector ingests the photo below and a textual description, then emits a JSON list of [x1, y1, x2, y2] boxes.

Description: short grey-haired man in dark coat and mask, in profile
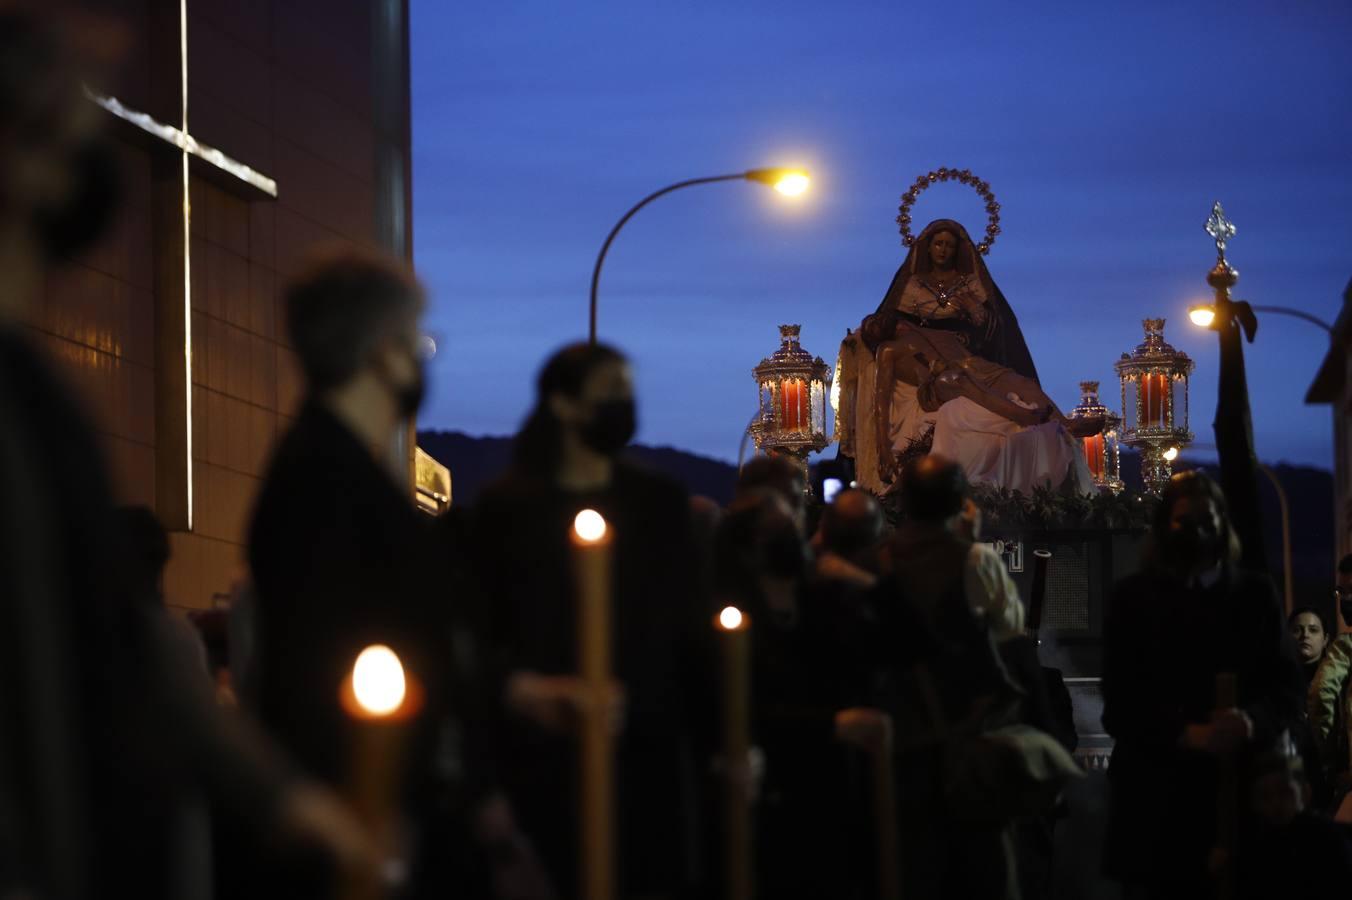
[[249, 251, 511, 896]]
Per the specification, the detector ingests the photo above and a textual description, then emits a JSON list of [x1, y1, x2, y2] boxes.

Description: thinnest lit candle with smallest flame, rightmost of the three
[[714, 607, 752, 900]]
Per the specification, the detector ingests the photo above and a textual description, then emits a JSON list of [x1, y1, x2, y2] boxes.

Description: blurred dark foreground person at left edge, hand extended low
[[0, 12, 373, 900]]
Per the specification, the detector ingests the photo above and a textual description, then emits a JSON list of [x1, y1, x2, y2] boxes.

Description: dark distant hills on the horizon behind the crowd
[[418, 431, 1336, 608]]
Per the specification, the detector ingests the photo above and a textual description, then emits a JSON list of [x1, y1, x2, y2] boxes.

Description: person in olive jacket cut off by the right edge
[[1307, 554, 1352, 823]]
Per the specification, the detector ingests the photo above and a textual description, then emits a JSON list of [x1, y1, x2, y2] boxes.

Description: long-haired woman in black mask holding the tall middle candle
[[469, 343, 717, 897]]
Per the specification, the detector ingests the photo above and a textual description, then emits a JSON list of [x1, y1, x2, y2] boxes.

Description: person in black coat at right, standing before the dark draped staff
[[1103, 472, 1302, 897]]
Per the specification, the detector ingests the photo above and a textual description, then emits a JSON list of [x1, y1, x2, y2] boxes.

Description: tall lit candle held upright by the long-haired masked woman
[[572, 509, 615, 900]]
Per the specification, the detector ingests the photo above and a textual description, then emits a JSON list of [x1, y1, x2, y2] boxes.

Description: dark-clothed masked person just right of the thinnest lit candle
[[714, 488, 887, 900]]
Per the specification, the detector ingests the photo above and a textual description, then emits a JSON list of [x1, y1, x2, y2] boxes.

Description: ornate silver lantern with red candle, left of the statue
[[748, 326, 831, 482]]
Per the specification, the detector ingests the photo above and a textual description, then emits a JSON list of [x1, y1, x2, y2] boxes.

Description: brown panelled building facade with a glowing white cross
[[25, 0, 414, 608]]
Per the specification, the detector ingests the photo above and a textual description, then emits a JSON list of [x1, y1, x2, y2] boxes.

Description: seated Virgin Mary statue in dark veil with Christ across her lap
[[837, 219, 1094, 493]]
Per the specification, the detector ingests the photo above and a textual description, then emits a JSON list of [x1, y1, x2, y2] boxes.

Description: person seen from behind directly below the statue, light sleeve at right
[[876, 454, 1076, 900]]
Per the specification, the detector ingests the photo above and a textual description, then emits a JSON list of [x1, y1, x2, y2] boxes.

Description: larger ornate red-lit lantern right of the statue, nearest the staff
[[1114, 319, 1194, 493]]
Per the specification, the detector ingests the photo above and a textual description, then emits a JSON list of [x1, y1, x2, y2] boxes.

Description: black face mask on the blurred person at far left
[[34, 138, 122, 259]]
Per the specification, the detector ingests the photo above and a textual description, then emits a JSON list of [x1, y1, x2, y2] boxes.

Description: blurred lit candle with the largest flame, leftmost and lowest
[[339, 643, 420, 900]]
